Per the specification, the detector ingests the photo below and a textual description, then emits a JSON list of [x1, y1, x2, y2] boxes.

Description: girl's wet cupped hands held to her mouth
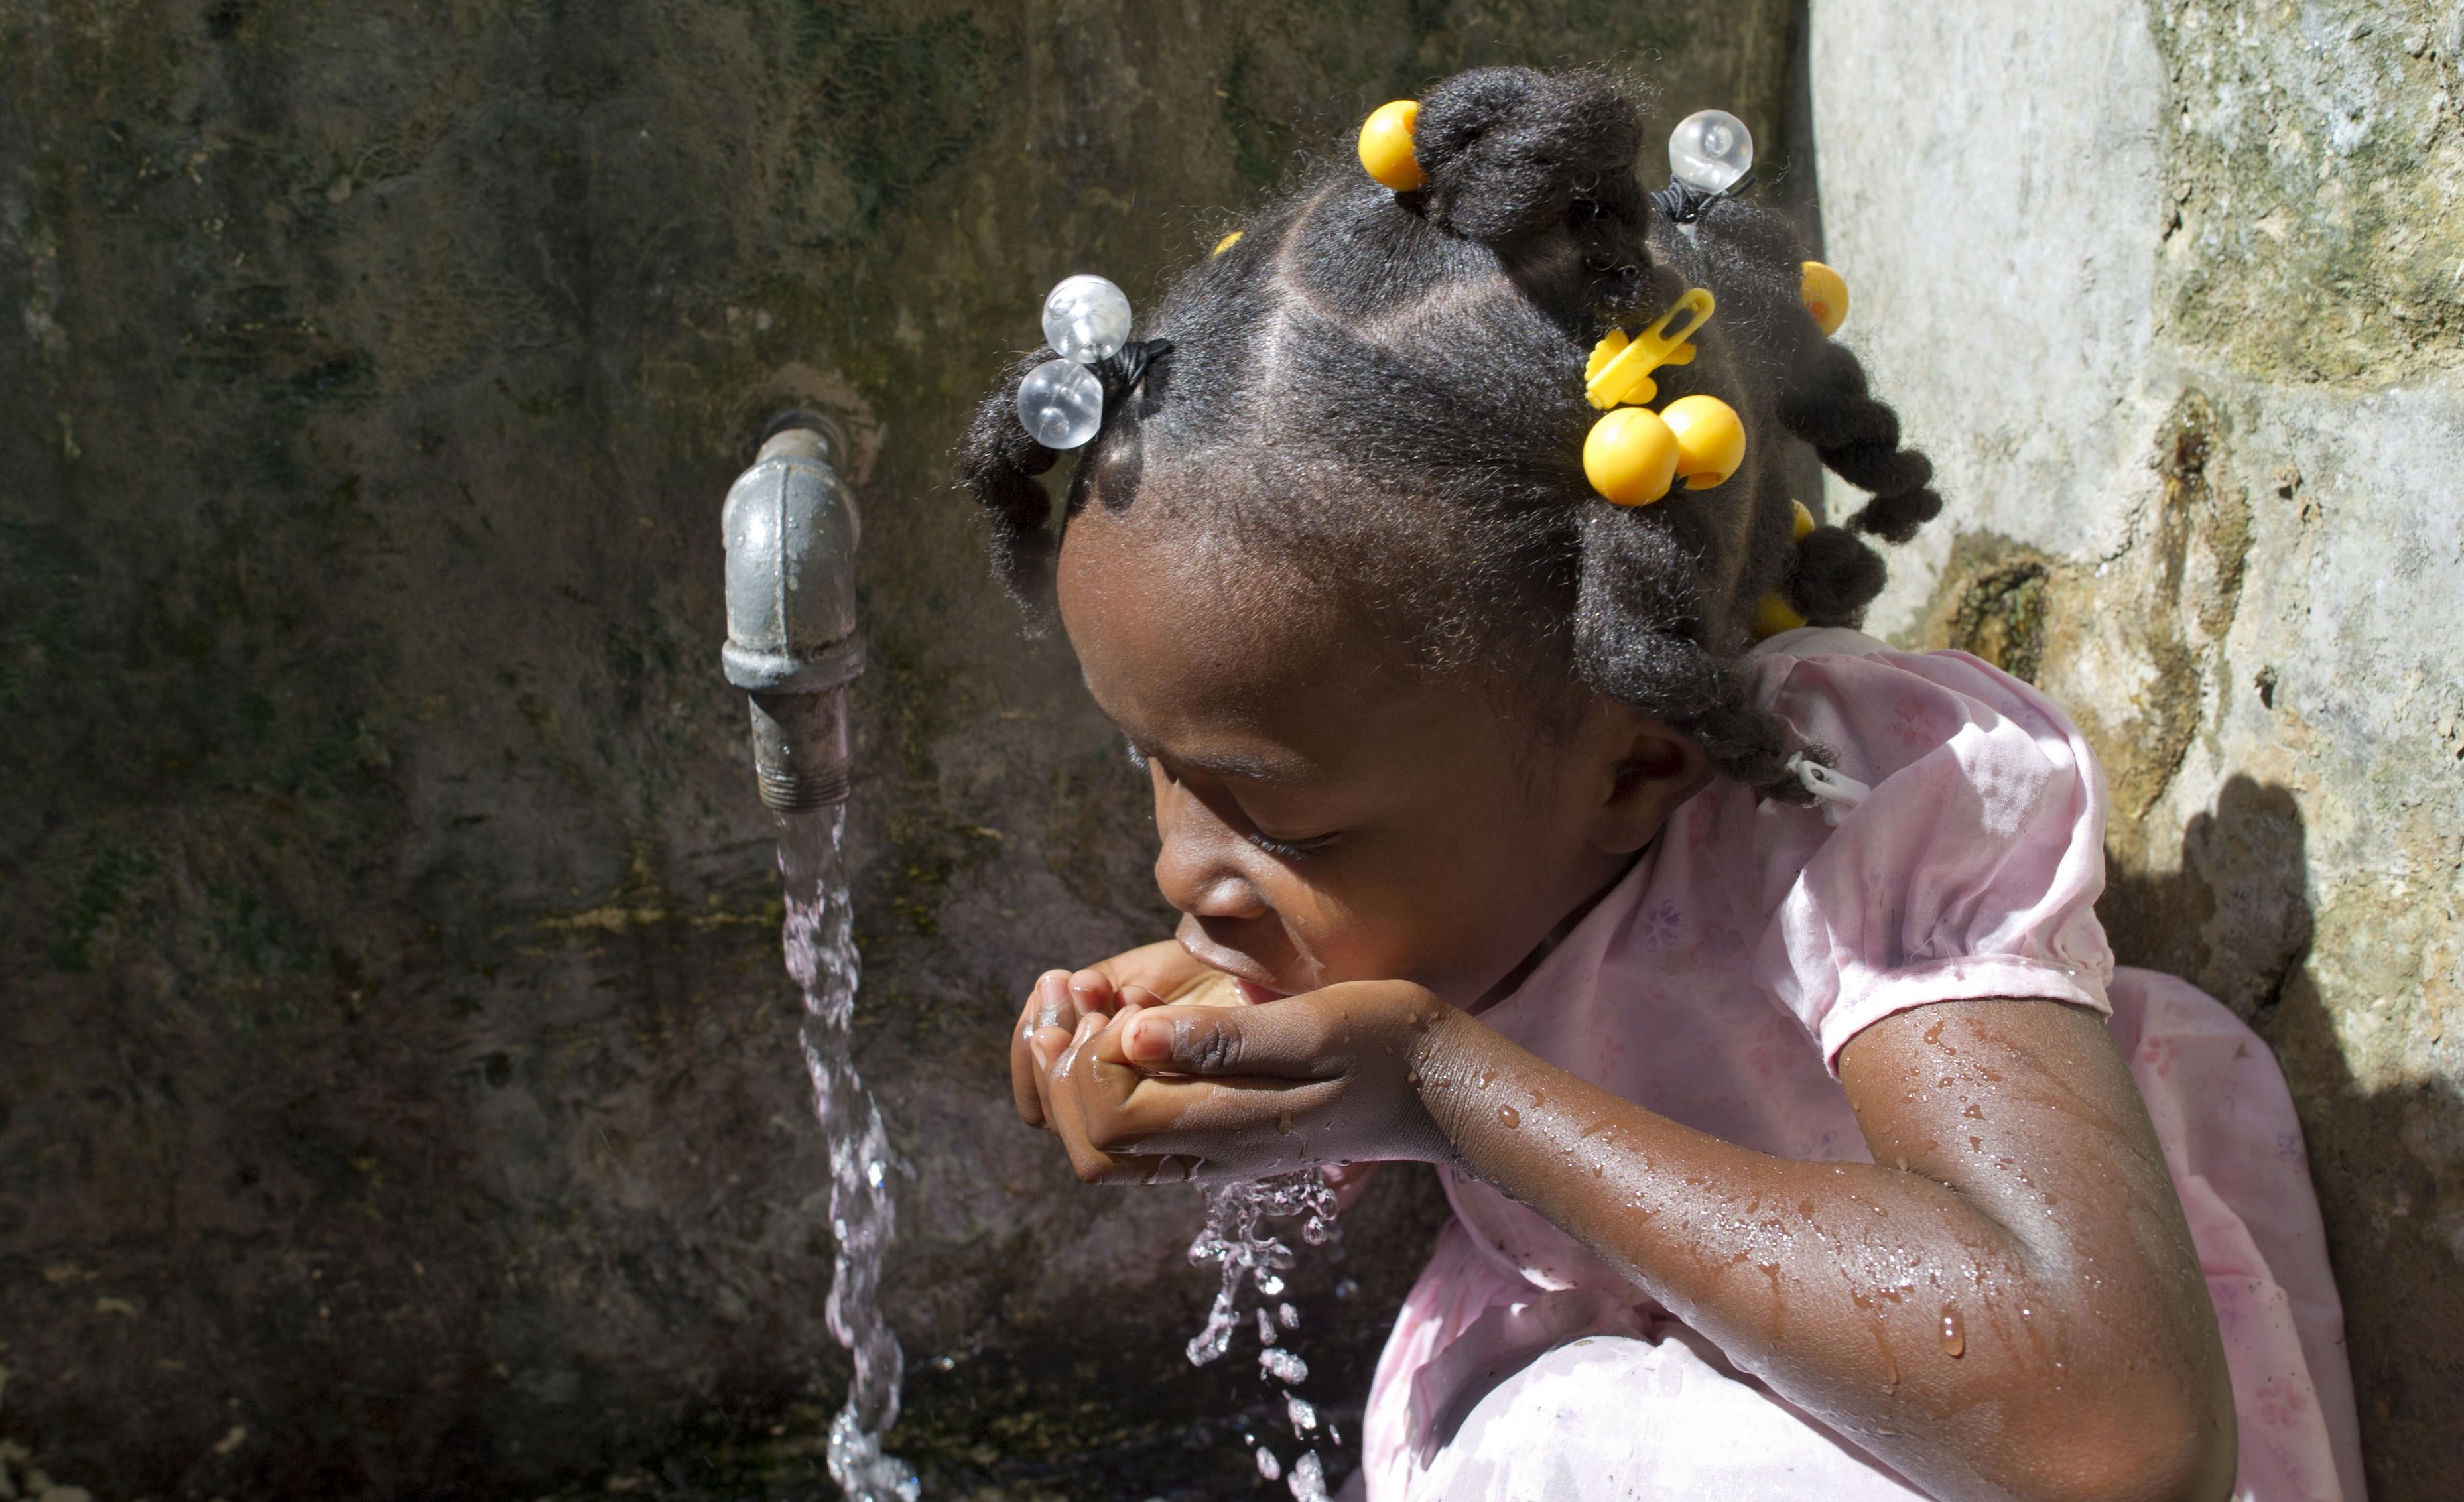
[[1033, 980, 1461, 1184]]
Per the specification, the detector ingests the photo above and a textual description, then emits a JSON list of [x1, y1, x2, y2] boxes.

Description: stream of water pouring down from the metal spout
[[779, 808, 921, 1502]]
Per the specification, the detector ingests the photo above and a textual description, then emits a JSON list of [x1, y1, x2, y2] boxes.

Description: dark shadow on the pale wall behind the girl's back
[[2097, 776, 2464, 1502]]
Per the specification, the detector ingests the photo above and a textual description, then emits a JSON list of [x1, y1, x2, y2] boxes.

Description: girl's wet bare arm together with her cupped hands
[[1030, 983, 2235, 1502]]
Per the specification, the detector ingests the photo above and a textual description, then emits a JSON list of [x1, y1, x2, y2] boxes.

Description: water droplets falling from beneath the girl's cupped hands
[[1188, 1170, 1340, 1502]]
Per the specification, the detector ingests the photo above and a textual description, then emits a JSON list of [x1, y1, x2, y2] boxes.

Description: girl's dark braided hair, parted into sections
[[958, 69, 1941, 802]]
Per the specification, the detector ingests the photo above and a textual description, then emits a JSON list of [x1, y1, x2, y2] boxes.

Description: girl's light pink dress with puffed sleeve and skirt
[[1348, 631, 2363, 1502]]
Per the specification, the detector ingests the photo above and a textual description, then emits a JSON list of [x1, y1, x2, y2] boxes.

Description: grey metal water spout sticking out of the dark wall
[[720, 411, 865, 812]]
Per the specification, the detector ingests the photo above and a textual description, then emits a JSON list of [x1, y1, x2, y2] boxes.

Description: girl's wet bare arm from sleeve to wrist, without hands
[[1419, 1002, 2235, 1499]]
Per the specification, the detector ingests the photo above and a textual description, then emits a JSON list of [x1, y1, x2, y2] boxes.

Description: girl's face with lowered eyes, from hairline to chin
[[1059, 502, 1707, 1007]]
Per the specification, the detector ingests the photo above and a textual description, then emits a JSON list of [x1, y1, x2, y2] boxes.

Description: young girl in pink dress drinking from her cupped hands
[[964, 69, 2361, 1502]]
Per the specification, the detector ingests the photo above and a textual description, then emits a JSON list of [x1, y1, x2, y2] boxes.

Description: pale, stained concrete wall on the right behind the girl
[[1811, 0, 2464, 1499]]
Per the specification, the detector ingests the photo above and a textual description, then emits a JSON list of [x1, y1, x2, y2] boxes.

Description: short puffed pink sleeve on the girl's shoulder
[[1752, 633, 2114, 1074]]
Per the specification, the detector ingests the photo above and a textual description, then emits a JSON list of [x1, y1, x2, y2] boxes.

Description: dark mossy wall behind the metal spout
[[0, 0, 1813, 1499]]
